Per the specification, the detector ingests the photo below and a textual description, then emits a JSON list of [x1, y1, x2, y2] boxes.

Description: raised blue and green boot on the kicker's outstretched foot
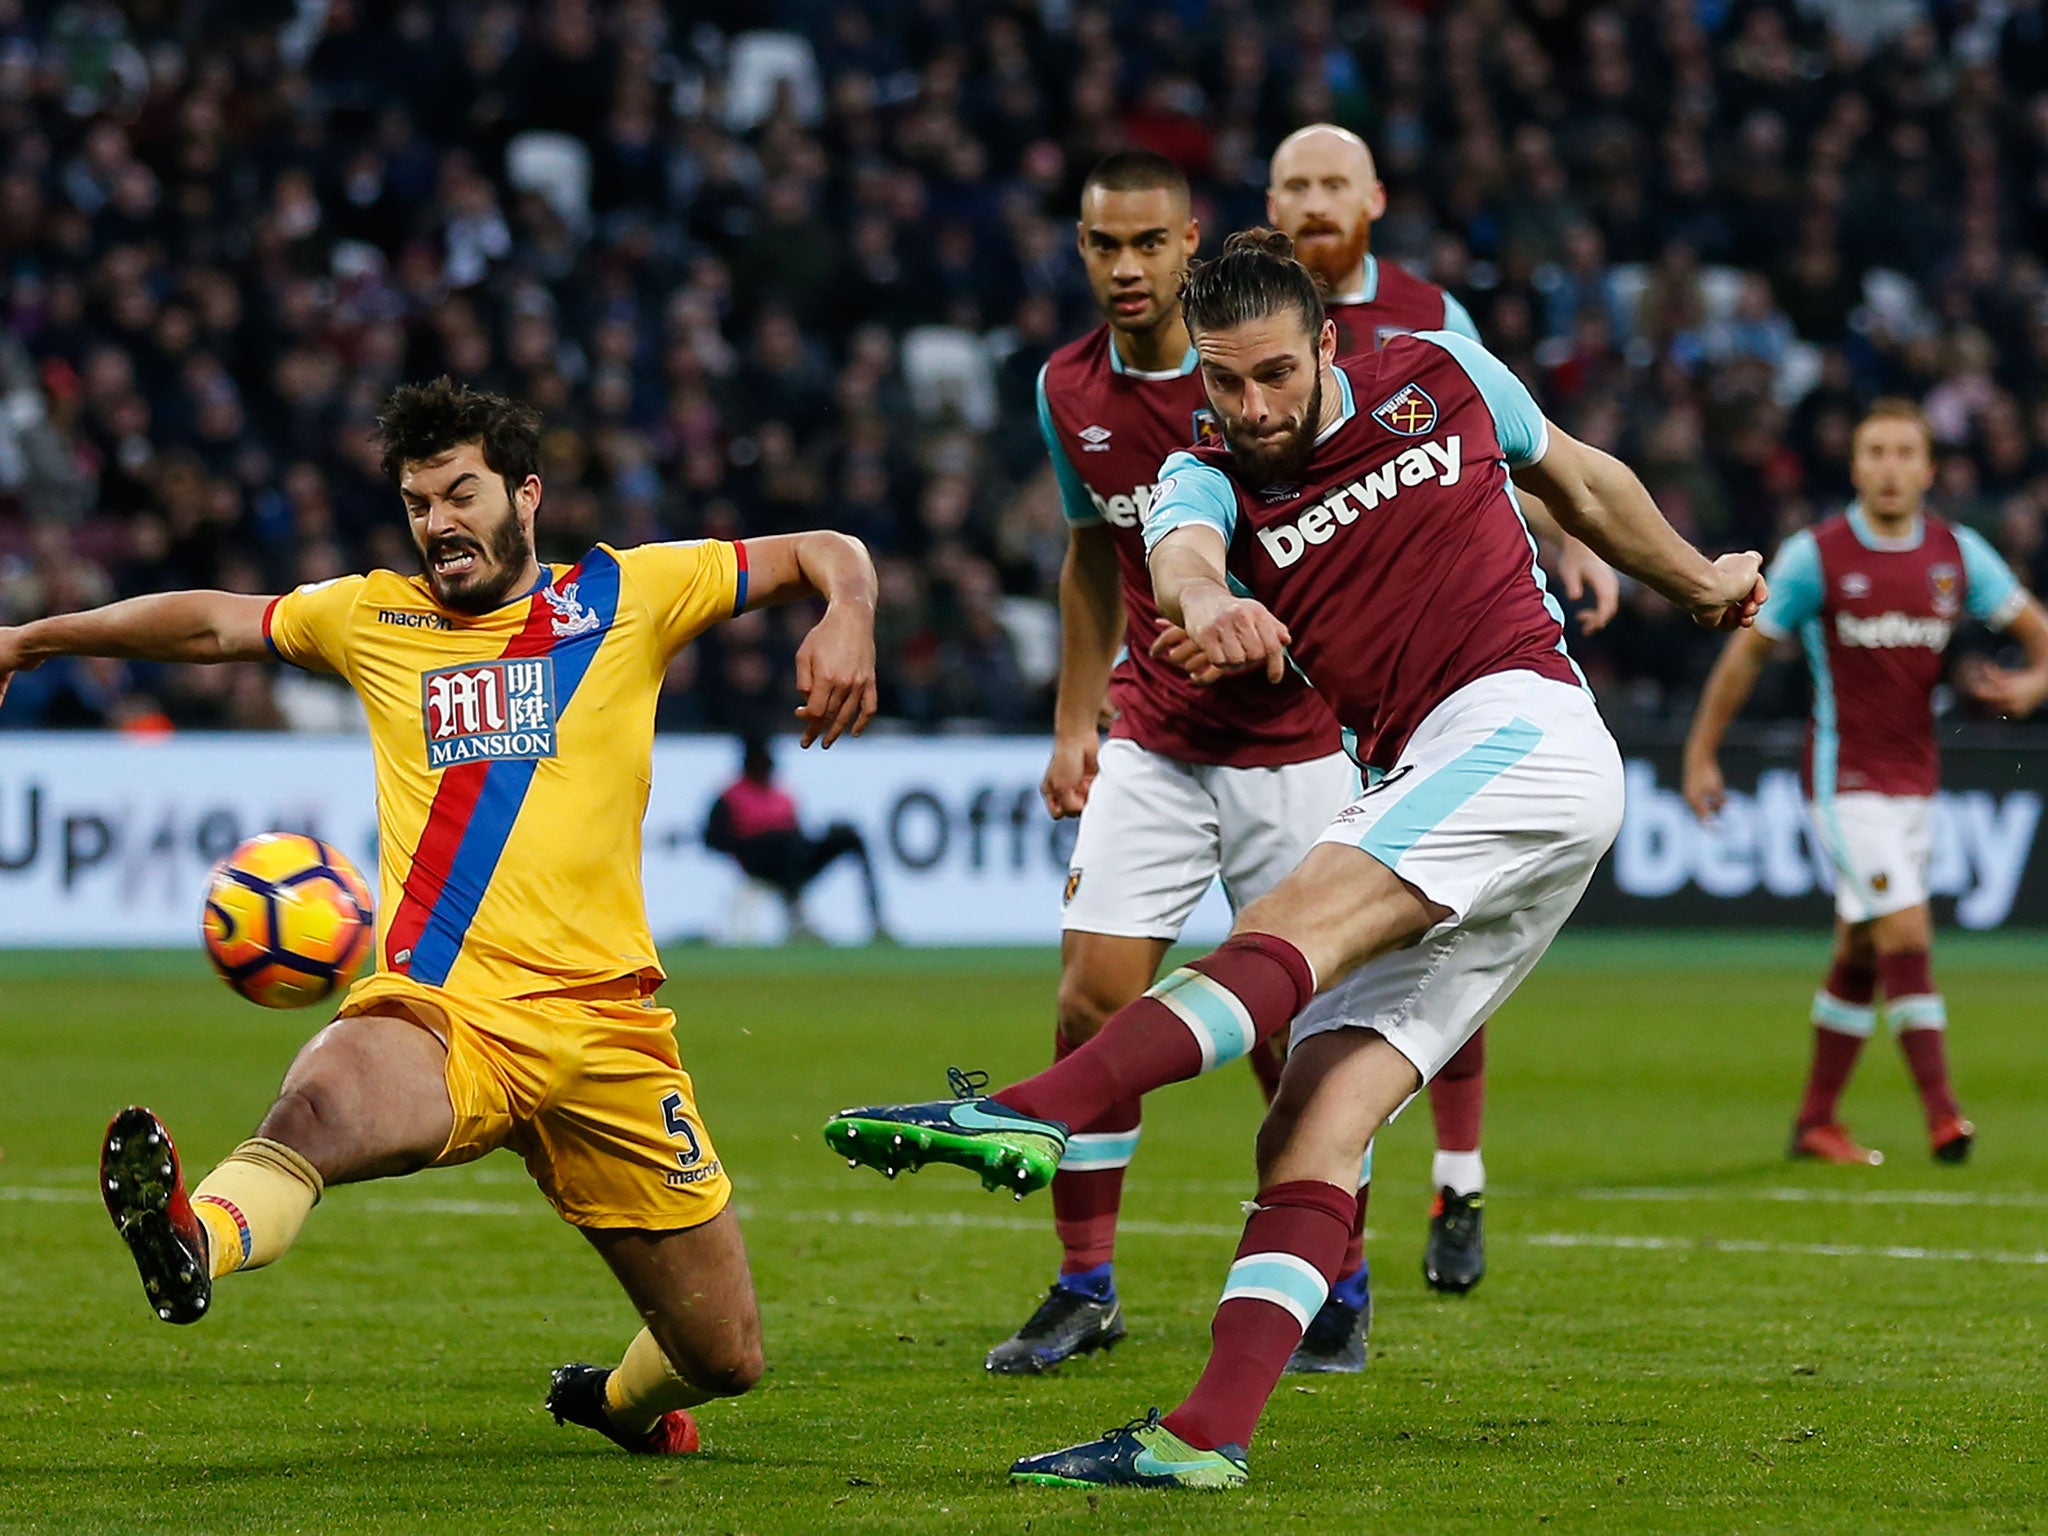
[[825, 1067, 1067, 1200]]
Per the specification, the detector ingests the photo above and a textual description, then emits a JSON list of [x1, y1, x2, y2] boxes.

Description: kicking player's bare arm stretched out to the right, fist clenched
[[1513, 422, 1767, 629]]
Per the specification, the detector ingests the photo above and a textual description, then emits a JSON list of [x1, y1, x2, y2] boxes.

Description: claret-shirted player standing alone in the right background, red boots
[[1686, 399, 2048, 1163]]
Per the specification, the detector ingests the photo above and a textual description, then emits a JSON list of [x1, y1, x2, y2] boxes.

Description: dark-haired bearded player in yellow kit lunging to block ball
[[0, 379, 874, 1452]]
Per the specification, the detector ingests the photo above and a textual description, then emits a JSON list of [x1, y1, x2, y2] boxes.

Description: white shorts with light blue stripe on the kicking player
[[1290, 672, 1622, 1081]]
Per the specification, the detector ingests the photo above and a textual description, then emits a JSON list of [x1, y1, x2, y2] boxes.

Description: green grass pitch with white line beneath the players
[[0, 938, 2048, 1534]]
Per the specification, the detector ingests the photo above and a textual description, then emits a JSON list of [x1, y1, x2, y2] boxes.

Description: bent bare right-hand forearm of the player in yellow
[[745, 530, 877, 748]]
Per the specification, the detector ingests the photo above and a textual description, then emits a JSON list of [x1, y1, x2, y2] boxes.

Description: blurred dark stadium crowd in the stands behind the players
[[0, 0, 2048, 729]]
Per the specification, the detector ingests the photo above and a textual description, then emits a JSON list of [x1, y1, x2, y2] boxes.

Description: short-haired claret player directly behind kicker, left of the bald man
[[1007, 150, 1368, 1374]]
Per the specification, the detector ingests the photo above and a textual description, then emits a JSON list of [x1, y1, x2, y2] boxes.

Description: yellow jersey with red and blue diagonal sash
[[264, 541, 748, 997]]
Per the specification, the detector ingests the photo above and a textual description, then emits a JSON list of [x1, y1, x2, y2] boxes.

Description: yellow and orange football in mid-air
[[201, 831, 377, 1008]]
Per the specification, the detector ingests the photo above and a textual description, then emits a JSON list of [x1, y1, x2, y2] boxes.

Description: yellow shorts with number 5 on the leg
[[340, 973, 733, 1231]]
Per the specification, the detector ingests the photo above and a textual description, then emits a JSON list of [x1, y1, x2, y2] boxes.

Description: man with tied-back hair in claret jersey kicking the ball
[[825, 229, 1765, 1487]]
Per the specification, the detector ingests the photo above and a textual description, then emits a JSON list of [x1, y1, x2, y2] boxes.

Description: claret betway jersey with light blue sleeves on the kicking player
[[1145, 332, 1583, 768]]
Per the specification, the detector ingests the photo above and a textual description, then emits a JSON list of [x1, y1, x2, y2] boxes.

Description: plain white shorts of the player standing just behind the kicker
[[1059, 737, 1358, 940]]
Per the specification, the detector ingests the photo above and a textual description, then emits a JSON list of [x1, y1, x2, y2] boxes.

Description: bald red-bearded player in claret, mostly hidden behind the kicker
[[1266, 123, 1620, 1292]]
